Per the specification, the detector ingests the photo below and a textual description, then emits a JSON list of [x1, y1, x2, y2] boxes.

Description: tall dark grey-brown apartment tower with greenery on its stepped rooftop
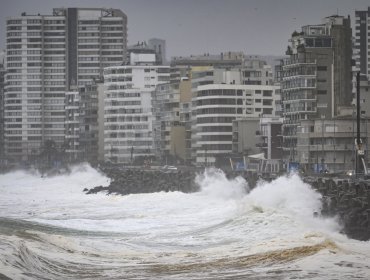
[[278, 16, 353, 164]]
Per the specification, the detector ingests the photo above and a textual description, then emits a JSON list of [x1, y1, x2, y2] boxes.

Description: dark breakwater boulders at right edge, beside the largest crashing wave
[[304, 177, 370, 240]]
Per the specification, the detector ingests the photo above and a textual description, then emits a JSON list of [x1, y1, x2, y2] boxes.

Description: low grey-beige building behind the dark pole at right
[[298, 116, 370, 172]]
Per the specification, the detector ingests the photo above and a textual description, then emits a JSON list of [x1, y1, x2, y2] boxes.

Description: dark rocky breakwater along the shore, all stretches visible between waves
[[83, 168, 370, 241]]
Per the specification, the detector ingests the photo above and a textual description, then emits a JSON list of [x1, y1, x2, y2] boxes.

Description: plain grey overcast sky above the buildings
[[0, 0, 370, 58]]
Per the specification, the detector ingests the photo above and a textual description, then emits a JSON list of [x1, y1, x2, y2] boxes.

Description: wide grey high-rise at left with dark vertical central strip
[[4, 8, 127, 162]]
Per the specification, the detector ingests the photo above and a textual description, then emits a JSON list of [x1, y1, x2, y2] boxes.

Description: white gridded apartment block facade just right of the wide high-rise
[[104, 65, 170, 163]]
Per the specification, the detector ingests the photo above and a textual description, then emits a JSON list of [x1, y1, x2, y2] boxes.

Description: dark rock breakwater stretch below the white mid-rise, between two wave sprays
[[84, 169, 199, 195]]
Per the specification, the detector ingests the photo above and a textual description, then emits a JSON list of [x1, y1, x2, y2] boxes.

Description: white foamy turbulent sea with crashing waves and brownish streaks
[[0, 165, 370, 280]]
